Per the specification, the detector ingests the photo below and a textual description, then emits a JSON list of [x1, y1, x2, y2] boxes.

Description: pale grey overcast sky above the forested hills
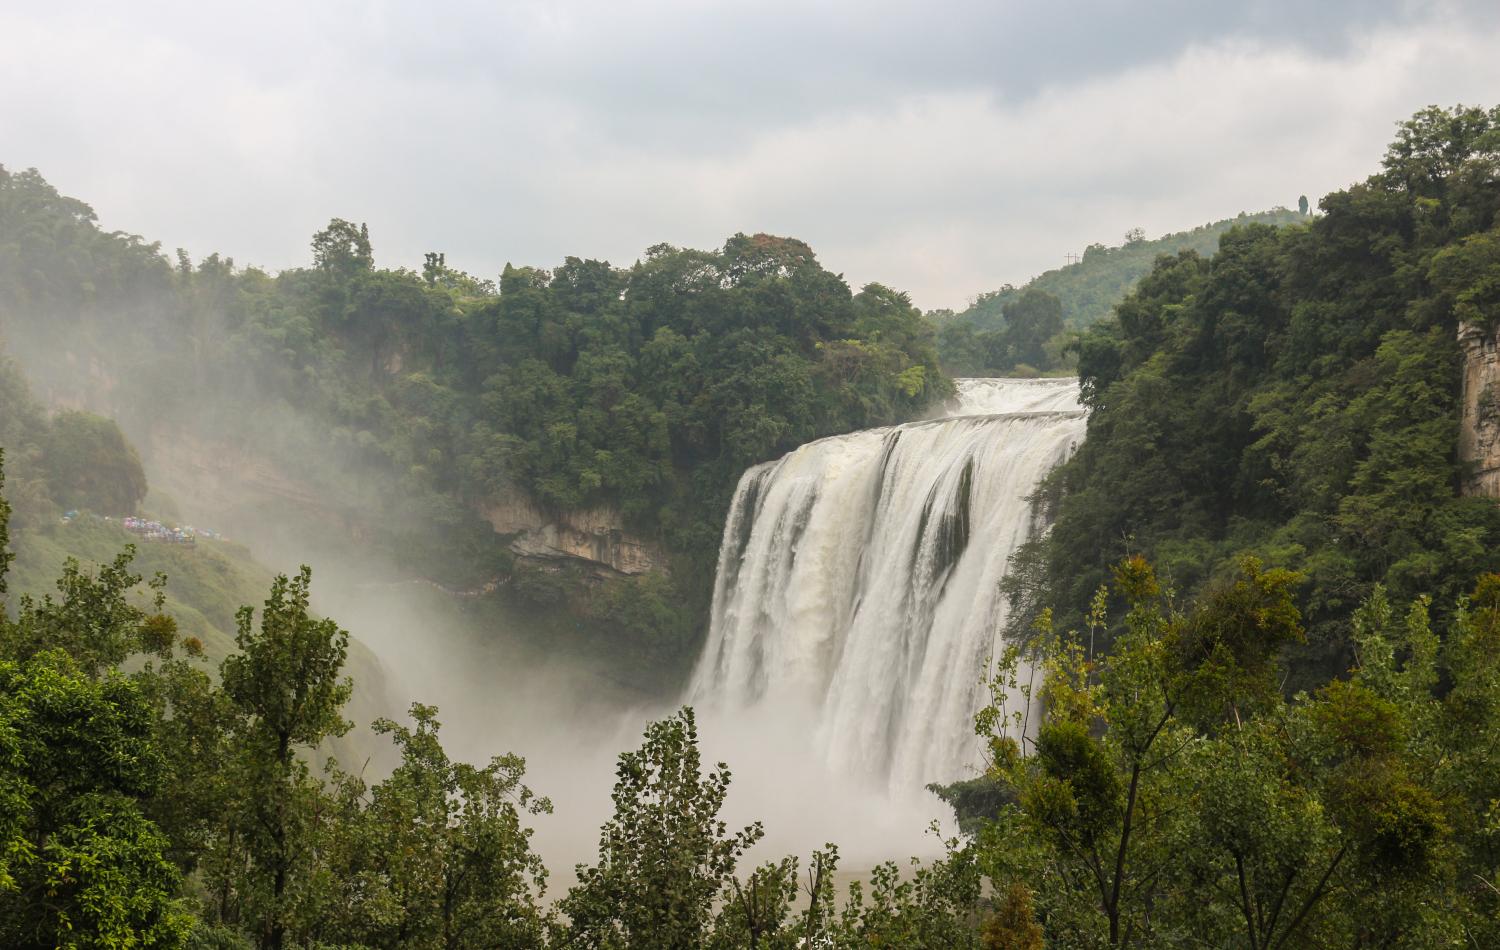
[[0, 0, 1500, 308]]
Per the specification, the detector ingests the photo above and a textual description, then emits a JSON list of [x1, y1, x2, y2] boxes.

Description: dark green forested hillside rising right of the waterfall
[[1016, 108, 1500, 684]]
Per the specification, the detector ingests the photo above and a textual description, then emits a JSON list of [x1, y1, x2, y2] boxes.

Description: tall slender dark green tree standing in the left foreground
[[221, 567, 351, 950]]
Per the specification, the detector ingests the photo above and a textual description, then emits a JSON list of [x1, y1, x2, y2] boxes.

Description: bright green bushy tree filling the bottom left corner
[[0, 648, 191, 950]]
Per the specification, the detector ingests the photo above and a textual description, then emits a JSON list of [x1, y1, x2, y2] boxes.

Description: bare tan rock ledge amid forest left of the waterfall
[[480, 494, 666, 575]]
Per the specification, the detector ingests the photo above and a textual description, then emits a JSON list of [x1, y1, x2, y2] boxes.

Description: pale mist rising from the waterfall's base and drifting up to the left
[[2, 282, 954, 896]]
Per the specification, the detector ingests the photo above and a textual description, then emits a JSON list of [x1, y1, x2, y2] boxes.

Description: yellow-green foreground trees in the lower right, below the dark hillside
[[977, 557, 1500, 950]]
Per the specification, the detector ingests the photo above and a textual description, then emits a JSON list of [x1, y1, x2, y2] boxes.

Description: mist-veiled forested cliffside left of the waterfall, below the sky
[[0, 170, 951, 662]]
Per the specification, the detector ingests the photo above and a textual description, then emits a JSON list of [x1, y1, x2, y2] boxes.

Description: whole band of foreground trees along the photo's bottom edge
[[14, 450, 1500, 950]]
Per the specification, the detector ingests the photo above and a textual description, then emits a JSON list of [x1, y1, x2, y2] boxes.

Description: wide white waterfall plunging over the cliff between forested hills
[[690, 373, 1085, 791]]
